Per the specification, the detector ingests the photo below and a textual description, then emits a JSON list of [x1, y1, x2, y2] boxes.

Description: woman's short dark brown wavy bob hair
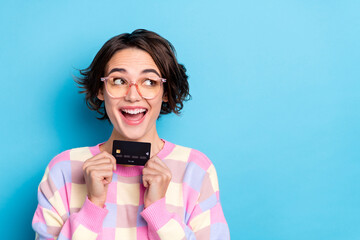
[[75, 29, 191, 121]]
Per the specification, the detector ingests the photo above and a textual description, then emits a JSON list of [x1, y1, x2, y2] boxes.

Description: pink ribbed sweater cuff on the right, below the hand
[[140, 197, 172, 231]]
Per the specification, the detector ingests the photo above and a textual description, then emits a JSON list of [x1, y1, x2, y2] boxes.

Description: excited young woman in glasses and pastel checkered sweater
[[32, 29, 230, 240]]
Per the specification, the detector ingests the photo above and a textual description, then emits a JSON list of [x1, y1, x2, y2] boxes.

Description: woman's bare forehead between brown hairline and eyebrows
[[105, 48, 160, 75]]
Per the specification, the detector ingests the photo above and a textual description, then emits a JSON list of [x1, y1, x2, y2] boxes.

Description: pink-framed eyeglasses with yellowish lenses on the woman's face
[[101, 77, 166, 99]]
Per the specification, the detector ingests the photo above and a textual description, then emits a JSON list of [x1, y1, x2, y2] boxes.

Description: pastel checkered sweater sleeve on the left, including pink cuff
[[32, 152, 108, 240]]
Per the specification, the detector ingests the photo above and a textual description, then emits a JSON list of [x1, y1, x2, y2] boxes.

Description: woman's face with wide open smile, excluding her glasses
[[98, 48, 167, 140]]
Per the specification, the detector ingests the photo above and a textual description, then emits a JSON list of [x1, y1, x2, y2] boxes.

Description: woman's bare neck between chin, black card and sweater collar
[[100, 128, 164, 157]]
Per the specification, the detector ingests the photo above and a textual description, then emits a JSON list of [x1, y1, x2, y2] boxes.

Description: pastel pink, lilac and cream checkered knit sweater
[[32, 140, 230, 240]]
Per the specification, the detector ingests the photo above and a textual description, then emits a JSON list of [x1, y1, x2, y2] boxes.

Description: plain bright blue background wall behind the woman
[[0, 0, 360, 240]]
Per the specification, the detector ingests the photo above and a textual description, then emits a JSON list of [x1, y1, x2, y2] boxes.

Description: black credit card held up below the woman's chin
[[112, 140, 151, 166]]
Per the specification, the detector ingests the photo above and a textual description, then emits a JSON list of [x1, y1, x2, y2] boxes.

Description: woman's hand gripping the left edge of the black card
[[83, 151, 116, 208]]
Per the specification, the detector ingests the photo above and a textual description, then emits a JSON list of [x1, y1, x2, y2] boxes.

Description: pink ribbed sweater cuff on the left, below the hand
[[76, 197, 109, 233]]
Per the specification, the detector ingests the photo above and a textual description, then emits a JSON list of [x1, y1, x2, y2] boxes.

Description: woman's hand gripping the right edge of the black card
[[142, 156, 172, 208]]
